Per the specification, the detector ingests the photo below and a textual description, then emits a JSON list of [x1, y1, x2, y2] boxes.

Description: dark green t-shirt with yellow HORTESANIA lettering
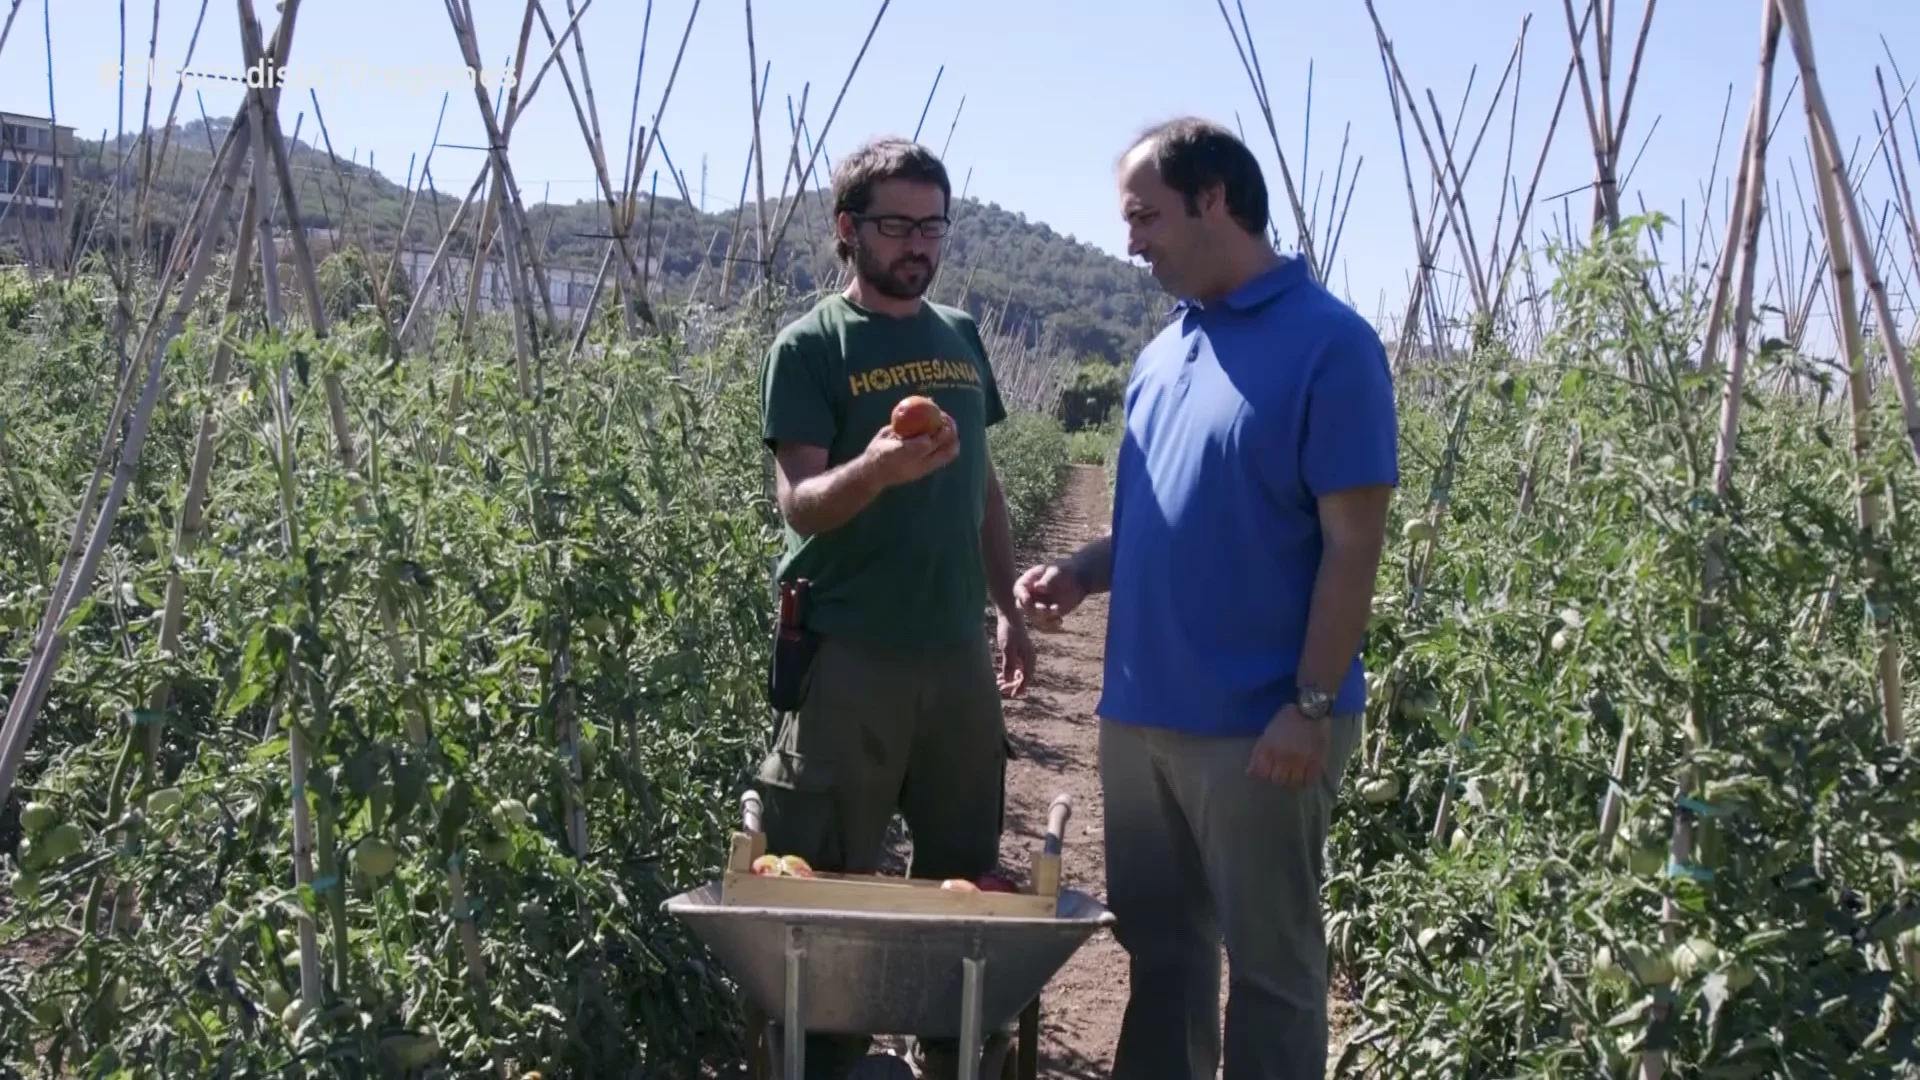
[[760, 294, 1006, 648]]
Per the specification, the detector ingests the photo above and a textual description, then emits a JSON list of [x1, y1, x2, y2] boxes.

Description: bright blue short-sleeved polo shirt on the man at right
[[1096, 258, 1400, 736]]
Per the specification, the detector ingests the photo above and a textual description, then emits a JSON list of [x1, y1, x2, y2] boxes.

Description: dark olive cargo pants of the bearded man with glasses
[[756, 632, 1006, 1080]]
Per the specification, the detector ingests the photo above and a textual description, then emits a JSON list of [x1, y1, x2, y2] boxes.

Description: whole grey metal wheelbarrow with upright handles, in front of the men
[[664, 792, 1114, 1080]]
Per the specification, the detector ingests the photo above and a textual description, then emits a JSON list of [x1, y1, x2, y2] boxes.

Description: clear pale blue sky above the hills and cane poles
[[0, 0, 1920, 332]]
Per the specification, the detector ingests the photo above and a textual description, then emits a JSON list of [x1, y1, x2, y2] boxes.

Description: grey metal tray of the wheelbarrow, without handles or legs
[[664, 880, 1114, 1038]]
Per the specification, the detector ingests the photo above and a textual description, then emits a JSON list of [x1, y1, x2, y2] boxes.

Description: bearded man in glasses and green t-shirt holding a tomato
[[758, 138, 1033, 1080]]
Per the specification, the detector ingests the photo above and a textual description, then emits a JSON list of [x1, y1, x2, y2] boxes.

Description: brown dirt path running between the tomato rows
[[1000, 457, 1127, 1080]]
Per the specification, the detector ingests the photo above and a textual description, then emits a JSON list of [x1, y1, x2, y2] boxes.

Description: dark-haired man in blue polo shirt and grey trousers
[[1016, 119, 1400, 1080]]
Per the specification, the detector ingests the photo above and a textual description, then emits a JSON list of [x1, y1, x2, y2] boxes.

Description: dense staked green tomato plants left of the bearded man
[[0, 261, 1066, 1076]]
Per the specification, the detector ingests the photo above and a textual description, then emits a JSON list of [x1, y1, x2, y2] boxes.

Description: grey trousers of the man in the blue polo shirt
[[1100, 715, 1361, 1080]]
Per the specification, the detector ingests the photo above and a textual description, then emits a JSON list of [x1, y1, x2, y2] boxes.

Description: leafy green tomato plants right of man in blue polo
[[1327, 214, 1920, 1078]]
